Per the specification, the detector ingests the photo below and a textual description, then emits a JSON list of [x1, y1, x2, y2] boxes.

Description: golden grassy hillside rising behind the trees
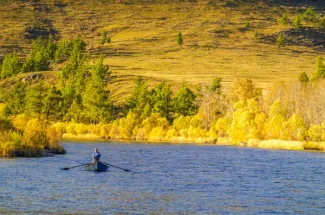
[[0, 0, 325, 101]]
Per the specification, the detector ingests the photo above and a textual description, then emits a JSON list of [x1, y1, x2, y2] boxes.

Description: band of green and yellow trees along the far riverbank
[[0, 34, 325, 154]]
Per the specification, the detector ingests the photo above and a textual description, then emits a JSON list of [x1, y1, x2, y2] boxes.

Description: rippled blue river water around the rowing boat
[[0, 143, 325, 215]]
